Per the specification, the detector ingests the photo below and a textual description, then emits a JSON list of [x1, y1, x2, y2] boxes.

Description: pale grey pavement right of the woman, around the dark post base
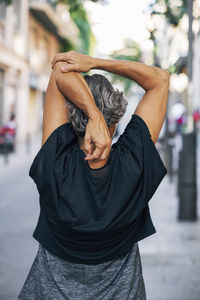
[[139, 173, 200, 300]]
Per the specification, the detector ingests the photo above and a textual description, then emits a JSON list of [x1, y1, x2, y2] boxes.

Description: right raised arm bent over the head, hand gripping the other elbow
[[52, 51, 170, 143]]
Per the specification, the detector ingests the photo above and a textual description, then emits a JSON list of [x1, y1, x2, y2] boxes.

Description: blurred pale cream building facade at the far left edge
[[0, 0, 29, 144]]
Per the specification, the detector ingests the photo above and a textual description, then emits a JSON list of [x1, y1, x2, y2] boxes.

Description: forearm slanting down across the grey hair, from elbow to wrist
[[53, 63, 101, 119]]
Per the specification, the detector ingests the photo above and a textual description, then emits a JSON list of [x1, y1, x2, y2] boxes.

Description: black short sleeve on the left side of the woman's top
[[29, 123, 77, 189]]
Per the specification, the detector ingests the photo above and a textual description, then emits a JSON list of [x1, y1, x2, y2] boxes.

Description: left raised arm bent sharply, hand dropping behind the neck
[[42, 63, 112, 160]]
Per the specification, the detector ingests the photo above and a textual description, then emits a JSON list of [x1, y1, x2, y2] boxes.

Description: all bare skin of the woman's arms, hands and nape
[[42, 51, 170, 168]]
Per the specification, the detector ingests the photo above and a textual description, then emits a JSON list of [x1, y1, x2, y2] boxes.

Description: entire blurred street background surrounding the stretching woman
[[0, 0, 200, 300]]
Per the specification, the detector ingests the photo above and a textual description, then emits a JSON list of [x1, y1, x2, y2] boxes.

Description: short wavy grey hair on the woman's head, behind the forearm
[[65, 74, 128, 137]]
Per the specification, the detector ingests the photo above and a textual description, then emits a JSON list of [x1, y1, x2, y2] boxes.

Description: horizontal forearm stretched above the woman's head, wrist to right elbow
[[91, 57, 169, 91]]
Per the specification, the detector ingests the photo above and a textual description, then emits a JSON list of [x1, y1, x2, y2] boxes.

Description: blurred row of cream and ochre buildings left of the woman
[[0, 0, 79, 143]]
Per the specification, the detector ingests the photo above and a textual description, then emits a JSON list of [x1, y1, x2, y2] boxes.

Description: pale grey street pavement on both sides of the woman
[[0, 136, 200, 300]]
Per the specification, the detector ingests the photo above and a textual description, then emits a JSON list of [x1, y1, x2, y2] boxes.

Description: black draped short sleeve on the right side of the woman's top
[[113, 114, 167, 208]]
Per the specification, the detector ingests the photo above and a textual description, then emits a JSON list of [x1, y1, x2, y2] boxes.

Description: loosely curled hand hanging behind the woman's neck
[[83, 115, 112, 161]]
